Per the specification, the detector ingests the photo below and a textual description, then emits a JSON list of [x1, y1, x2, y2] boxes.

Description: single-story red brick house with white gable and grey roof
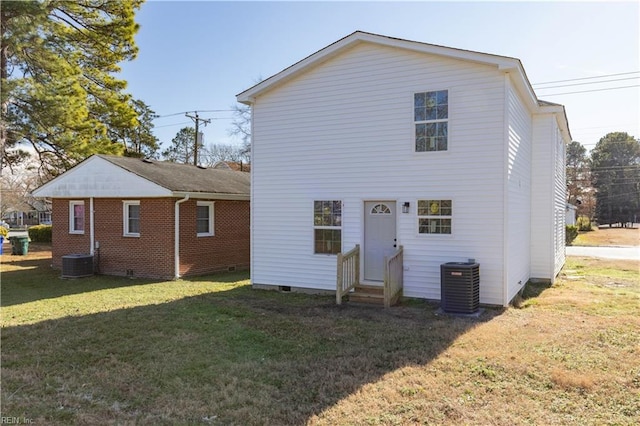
[[33, 155, 250, 279]]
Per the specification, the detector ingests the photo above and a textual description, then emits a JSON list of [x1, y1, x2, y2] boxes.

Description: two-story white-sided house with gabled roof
[[237, 32, 571, 305]]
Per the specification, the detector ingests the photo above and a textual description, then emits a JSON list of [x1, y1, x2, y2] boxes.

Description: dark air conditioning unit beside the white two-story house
[[440, 262, 480, 314]]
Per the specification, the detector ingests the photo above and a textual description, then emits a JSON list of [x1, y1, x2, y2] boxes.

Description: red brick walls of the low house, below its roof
[[52, 198, 250, 279]]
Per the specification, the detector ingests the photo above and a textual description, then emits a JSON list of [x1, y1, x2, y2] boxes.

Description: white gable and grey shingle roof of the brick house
[[33, 155, 250, 199]]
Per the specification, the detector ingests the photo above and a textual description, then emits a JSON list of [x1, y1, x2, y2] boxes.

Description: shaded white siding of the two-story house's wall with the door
[[251, 43, 504, 305]]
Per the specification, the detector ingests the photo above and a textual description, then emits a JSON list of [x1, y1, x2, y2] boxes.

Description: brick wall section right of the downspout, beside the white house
[[180, 200, 250, 275]]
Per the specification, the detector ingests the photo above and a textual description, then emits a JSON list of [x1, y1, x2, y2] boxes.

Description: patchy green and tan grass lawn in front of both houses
[[1, 247, 640, 425]]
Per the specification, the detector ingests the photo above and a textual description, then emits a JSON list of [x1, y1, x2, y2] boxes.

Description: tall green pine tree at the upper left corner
[[0, 0, 142, 173]]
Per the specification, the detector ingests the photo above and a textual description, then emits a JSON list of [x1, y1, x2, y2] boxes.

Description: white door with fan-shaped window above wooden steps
[[364, 201, 396, 281]]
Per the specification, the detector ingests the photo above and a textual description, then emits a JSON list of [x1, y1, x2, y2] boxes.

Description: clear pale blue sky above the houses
[[121, 0, 640, 153]]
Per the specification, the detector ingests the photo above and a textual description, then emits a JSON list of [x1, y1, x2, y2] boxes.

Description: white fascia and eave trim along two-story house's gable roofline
[[236, 31, 533, 105]]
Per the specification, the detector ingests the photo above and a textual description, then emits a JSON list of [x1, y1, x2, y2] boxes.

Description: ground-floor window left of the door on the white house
[[313, 201, 342, 254]]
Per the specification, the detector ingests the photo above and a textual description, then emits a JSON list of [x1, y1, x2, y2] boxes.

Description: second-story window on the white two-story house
[[413, 90, 449, 152]]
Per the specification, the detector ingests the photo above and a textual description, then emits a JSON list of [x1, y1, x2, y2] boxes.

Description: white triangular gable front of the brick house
[[32, 156, 172, 198]]
